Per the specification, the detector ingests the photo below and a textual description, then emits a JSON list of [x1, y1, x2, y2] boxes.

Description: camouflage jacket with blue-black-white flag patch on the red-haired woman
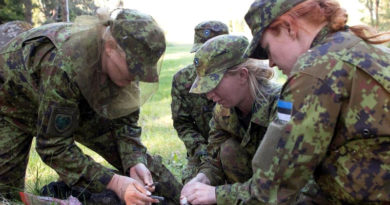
[[232, 29, 390, 204]]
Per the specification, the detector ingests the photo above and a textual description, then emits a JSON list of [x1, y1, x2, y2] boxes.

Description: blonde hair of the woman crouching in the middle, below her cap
[[227, 58, 274, 101]]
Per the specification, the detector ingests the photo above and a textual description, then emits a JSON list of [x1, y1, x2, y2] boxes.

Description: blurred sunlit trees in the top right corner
[[359, 0, 390, 31]]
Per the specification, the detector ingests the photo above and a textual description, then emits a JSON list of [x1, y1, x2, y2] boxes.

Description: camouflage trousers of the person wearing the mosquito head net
[[0, 118, 182, 204]]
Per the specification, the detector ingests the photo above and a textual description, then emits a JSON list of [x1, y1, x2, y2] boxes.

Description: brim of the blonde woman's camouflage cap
[[190, 71, 225, 94]]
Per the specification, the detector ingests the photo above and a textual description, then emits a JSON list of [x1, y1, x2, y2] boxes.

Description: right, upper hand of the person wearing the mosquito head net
[[130, 163, 155, 192]]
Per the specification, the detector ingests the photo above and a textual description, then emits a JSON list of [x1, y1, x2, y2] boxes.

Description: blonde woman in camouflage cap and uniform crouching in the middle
[[182, 35, 280, 204]]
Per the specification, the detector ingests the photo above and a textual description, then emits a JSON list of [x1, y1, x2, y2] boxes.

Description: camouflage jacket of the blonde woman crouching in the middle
[[199, 80, 280, 204]]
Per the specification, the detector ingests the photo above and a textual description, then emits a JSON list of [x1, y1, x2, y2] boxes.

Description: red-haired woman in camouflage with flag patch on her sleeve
[[235, 0, 390, 204]]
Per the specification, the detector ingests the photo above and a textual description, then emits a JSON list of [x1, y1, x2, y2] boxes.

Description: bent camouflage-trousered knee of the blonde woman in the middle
[[220, 137, 253, 183]]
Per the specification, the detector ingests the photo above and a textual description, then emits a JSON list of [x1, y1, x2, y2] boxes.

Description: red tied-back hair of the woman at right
[[269, 0, 390, 44]]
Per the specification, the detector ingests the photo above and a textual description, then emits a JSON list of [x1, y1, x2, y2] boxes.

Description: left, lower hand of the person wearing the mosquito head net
[[107, 174, 159, 205]]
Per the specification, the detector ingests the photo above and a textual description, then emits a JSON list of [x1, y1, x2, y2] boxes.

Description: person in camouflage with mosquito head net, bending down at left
[[0, 10, 181, 204]]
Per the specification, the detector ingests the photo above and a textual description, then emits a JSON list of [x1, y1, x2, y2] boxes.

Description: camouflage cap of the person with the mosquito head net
[[111, 9, 166, 82]]
